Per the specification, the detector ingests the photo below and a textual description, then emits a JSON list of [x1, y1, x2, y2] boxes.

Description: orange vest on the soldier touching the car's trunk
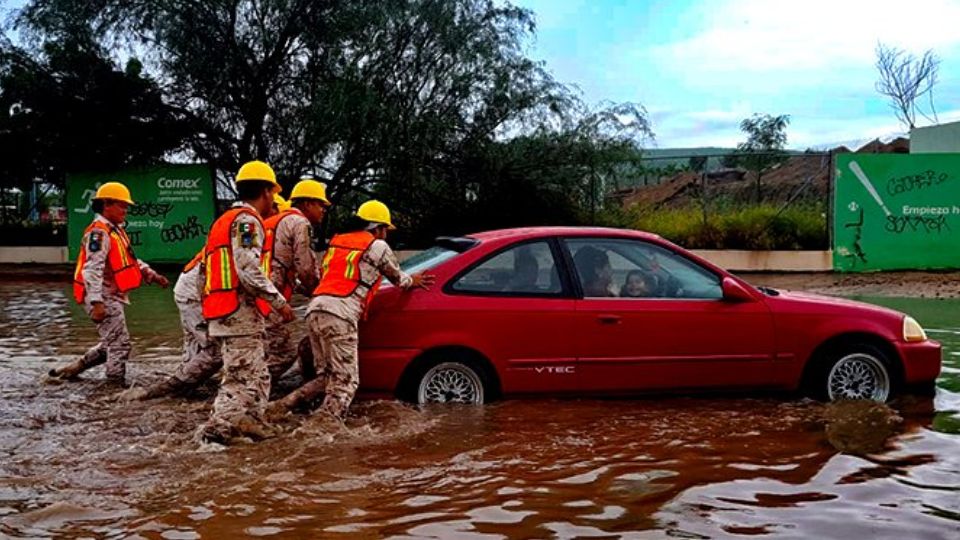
[[313, 231, 383, 315]]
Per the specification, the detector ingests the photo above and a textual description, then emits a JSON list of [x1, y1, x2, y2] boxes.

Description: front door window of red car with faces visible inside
[[564, 238, 723, 299]]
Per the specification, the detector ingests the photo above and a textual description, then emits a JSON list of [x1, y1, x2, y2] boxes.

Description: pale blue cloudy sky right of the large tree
[[515, 0, 960, 149]]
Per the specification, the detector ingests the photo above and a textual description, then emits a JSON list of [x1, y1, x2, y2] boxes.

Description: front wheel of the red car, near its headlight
[[814, 343, 894, 403]]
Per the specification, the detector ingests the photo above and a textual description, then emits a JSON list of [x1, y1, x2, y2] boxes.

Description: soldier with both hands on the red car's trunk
[[271, 201, 435, 419]]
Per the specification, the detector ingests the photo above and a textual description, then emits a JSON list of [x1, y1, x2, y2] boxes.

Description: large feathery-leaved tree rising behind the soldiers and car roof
[[18, 0, 651, 237]]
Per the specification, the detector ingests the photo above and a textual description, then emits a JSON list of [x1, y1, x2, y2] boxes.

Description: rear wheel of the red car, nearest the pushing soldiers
[[414, 355, 490, 405]]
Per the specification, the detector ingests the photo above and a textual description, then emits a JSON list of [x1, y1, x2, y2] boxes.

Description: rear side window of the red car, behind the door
[[452, 241, 563, 296]]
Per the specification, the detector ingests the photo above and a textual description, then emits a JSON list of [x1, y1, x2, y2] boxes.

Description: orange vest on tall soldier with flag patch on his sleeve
[[201, 207, 270, 319]]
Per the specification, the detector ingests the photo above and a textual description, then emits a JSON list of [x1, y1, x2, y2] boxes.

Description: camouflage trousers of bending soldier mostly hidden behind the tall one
[[160, 300, 223, 393]]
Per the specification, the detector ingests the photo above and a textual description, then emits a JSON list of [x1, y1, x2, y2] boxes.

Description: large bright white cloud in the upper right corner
[[650, 0, 960, 74]]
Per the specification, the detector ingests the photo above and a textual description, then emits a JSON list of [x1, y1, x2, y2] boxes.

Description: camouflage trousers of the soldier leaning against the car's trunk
[[301, 311, 360, 418]]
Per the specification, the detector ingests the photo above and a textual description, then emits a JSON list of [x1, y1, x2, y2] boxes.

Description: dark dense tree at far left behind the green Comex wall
[[0, 34, 186, 220]]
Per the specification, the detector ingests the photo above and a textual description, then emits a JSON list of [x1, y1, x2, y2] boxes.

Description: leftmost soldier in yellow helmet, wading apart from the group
[[49, 182, 169, 386]]
